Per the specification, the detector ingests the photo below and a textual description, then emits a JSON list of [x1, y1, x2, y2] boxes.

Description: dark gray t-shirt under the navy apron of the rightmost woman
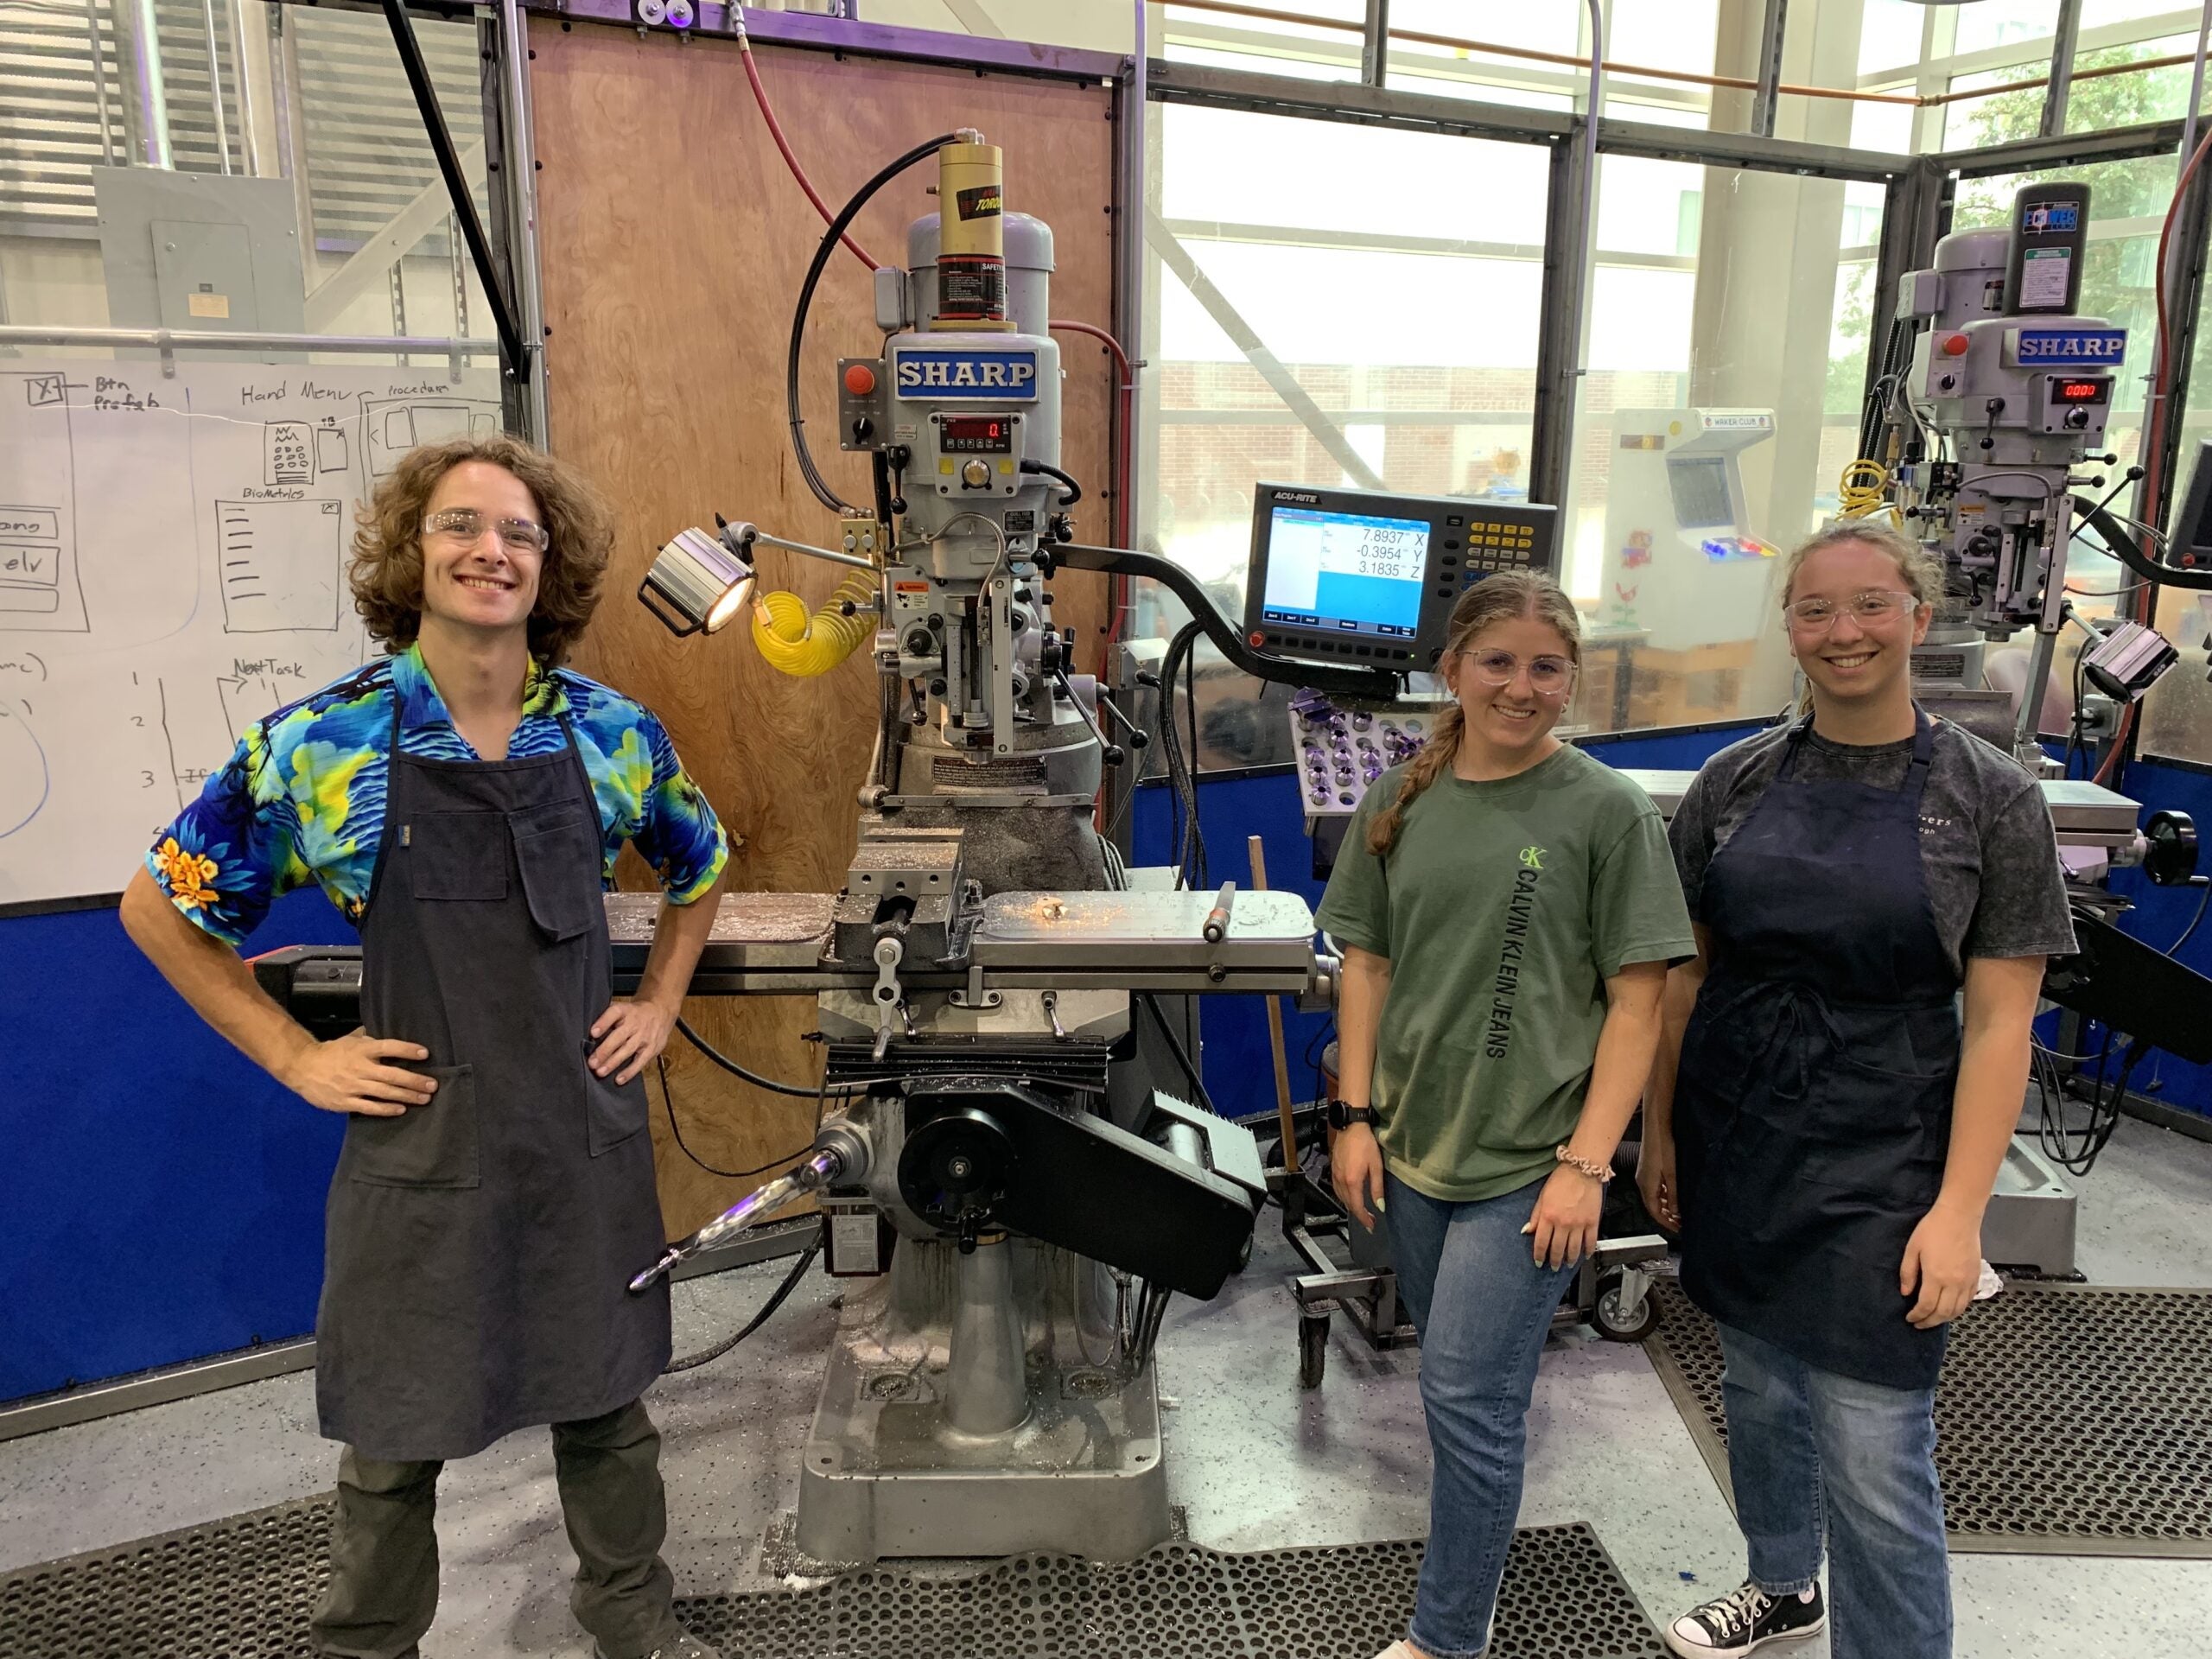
[[1668, 721, 2075, 980]]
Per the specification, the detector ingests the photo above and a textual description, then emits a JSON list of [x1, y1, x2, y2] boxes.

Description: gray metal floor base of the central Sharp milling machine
[[797, 1239, 1173, 1561]]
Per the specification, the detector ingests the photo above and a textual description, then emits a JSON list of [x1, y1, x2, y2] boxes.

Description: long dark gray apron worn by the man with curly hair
[[315, 690, 671, 1460]]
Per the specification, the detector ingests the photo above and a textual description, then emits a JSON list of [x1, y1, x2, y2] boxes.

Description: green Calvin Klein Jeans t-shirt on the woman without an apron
[[1319, 747, 1697, 1204]]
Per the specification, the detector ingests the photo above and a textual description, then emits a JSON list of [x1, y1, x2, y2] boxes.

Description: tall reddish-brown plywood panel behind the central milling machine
[[531, 24, 1115, 1234]]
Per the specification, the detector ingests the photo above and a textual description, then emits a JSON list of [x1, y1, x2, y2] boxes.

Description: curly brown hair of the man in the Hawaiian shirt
[[347, 431, 615, 666]]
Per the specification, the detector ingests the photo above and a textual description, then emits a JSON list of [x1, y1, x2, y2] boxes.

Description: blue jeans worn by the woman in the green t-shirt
[[1385, 1173, 1573, 1659]]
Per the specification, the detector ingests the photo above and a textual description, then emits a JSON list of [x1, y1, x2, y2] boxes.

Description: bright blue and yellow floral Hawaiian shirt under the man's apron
[[146, 646, 730, 944]]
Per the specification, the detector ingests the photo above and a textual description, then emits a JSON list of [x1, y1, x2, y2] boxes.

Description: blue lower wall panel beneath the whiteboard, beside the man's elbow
[[0, 892, 354, 1400]]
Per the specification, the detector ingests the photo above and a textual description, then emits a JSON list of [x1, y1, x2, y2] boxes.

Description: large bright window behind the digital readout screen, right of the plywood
[[1135, 104, 1548, 767]]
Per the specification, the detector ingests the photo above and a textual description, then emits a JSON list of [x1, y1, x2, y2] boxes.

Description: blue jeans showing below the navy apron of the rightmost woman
[[1721, 1325, 1951, 1659]]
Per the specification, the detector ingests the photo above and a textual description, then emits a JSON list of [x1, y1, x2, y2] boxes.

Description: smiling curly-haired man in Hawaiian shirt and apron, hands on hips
[[122, 435, 728, 1659]]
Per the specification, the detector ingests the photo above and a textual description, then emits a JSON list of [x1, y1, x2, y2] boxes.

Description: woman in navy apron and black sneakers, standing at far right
[[1639, 520, 2073, 1659]]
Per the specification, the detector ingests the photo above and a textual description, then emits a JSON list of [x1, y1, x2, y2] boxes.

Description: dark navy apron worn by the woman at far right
[[1675, 710, 1960, 1389]]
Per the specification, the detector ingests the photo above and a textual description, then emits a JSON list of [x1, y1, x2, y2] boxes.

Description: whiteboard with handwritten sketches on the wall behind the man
[[0, 359, 500, 905]]
